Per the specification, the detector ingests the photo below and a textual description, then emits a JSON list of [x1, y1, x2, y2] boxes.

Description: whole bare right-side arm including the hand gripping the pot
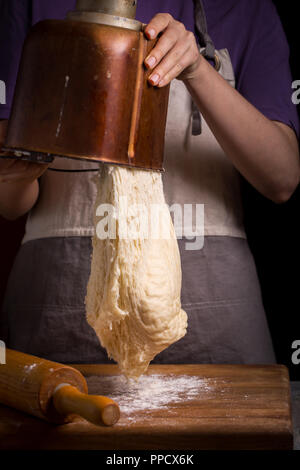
[[145, 14, 300, 203]]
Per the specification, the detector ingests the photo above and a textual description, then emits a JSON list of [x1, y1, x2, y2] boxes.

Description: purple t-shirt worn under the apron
[[0, 0, 299, 133]]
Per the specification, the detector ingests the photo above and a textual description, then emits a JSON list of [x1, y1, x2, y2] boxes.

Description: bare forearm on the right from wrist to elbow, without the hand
[[185, 59, 300, 203]]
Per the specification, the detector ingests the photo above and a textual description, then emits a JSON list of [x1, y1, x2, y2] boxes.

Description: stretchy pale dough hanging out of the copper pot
[[86, 165, 187, 378]]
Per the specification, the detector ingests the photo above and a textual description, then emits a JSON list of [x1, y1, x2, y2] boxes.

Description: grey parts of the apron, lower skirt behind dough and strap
[[0, 1, 275, 364]]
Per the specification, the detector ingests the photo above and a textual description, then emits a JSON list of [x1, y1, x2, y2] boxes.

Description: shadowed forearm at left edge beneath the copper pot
[[0, 121, 48, 220]]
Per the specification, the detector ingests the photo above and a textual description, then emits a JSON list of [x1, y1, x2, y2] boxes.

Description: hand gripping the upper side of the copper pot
[[144, 13, 203, 87]]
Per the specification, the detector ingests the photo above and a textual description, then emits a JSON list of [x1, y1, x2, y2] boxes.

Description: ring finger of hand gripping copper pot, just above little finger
[[149, 42, 191, 85]]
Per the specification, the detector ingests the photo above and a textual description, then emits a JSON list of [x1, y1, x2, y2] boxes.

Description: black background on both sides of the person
[[0, 0, 300, 380]]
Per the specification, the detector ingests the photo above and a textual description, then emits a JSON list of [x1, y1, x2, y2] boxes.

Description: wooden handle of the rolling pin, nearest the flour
[[53, 384, 120, 426]]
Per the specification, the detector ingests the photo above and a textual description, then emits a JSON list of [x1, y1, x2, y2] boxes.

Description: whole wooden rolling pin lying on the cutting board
[[0, 349, 120, 426]]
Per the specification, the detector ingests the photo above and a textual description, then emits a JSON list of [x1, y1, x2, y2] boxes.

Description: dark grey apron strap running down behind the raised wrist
[[192, 0, 215, 135]]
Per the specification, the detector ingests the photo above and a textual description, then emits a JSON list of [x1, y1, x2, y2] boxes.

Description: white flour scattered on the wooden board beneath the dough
[[87, 374, 212, 415]]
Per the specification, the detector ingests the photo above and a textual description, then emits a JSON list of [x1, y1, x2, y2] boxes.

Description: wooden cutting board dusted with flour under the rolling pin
[[0, 365, 293, 450]]
